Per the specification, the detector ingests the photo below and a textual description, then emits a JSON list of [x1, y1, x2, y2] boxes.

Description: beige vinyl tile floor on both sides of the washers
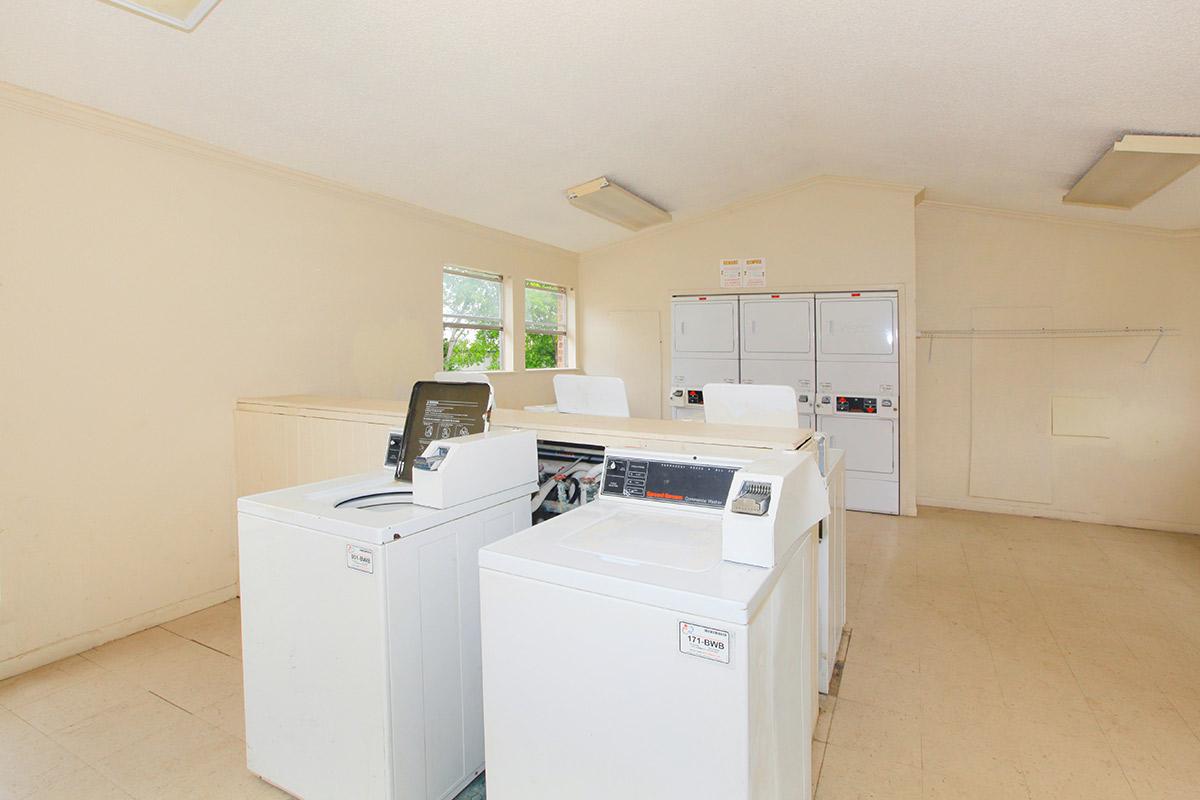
[[0, 509, 1200, 800]]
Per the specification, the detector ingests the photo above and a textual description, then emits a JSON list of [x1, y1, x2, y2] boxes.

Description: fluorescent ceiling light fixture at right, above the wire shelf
[[1062, 133, 1200, 210]]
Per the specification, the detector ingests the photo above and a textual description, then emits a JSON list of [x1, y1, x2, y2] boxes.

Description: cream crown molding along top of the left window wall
[[0, 82, 578, 259]]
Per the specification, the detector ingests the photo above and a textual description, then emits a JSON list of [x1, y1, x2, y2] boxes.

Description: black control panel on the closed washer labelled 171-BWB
[[601, 453, 740, 509]]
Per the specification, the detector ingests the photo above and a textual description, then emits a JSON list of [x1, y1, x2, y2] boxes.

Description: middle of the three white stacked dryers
[[739, 294, 817, 428]]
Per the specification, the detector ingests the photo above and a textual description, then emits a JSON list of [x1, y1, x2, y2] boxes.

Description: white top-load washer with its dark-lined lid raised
[[238, 431, 538, 800]]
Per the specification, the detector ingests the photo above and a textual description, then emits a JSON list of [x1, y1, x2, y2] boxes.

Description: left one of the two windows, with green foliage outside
[[442, 266, 504, 371]]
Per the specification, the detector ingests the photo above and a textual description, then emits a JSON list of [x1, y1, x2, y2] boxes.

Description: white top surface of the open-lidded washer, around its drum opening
[[238, 469, 536, 545]]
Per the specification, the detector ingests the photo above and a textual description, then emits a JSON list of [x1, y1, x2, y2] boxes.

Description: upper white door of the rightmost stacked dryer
[[817, 293, 900, 361]]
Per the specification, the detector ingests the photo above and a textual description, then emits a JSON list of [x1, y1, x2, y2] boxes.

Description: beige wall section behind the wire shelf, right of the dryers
[[917, 204, 1200, 531]]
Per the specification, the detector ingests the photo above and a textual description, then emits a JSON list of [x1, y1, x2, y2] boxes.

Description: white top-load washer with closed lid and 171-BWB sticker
[[479, 450, 828, 800]]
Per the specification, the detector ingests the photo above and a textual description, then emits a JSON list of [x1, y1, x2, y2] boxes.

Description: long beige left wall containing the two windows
[[0, 89, 577, 676]]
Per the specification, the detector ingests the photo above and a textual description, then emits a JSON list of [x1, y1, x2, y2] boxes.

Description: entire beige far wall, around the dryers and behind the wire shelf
[[580, 179, 1200, 531]]
